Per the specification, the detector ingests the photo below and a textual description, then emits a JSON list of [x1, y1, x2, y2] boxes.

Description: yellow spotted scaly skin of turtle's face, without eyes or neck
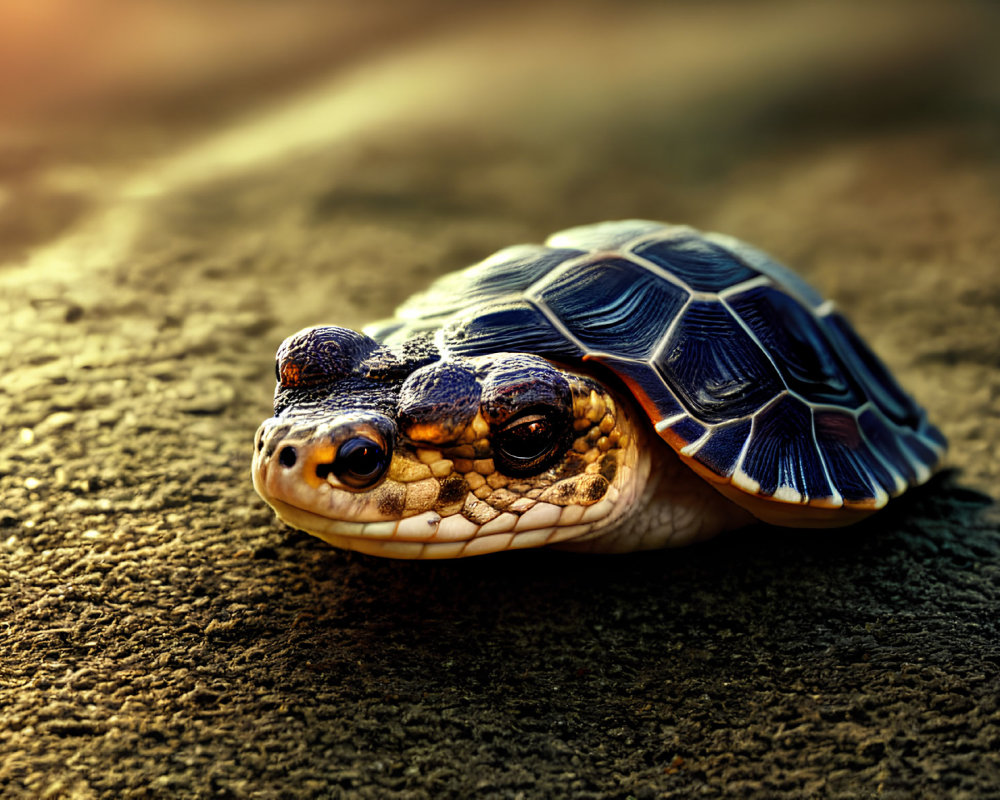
[[253, 359, 620, 558]]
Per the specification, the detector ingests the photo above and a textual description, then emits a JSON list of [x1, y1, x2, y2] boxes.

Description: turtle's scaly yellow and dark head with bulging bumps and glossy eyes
[[253, 327, 649, 558]]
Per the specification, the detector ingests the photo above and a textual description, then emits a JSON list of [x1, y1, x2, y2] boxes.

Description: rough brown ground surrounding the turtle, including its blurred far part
[[0, 0, 1000, 799]]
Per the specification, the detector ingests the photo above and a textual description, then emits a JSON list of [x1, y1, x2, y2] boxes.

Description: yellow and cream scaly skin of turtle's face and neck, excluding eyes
[[253, 357, 748, 558]]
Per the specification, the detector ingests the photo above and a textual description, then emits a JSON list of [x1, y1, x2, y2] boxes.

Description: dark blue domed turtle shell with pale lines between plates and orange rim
[[366, 220, 946, 518]]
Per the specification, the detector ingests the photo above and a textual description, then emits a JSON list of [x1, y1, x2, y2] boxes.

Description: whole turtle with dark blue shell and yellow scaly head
[[252, 220, 947, 558]]
